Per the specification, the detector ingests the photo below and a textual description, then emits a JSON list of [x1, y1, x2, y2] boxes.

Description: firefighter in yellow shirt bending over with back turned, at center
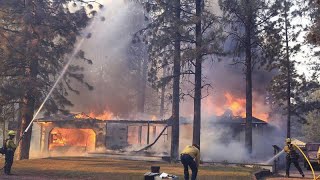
[[180, 144, 200, 180]]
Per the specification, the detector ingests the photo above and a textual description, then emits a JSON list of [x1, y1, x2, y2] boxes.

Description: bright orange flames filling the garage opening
[[49, 128, 96, 151]]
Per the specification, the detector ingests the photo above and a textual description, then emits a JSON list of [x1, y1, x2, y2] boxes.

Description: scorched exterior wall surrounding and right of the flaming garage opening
[[35, 120, 170, 155]]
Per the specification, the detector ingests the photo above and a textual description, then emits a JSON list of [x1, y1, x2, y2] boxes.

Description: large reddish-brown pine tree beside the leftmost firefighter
[[0, 0, 102, 159]]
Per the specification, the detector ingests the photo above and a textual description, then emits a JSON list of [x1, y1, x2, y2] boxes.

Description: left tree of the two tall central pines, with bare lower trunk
[[134, 0, 181, 160]]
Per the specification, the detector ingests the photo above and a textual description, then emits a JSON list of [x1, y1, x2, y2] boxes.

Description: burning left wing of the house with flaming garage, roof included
[[33, 113, 167, 153]]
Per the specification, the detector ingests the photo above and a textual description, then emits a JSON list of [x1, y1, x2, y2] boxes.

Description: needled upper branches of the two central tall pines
[[133, 0, 224, 88]]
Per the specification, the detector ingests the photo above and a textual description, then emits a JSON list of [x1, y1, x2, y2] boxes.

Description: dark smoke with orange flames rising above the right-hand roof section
[[181, 57, 279, 122]]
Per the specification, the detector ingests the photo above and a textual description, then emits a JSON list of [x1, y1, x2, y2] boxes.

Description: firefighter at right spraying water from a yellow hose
[[284, 138, 304, 177]]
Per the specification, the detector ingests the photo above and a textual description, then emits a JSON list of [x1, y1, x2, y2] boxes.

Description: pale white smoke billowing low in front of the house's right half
[[180, 118, 284, 163]]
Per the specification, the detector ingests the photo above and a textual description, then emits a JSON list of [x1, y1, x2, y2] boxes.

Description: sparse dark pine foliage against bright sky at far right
[[263, 0, 320, 123]]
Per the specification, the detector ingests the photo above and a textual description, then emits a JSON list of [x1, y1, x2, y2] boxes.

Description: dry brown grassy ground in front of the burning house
[[0, 157, 255, 180]]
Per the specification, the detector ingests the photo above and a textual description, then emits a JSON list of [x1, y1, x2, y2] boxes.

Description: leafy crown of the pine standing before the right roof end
[[219, 0, 277, 65]]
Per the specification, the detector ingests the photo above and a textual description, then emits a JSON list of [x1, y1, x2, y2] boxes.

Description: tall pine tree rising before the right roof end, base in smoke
[[219, 0, 277, 153]]
